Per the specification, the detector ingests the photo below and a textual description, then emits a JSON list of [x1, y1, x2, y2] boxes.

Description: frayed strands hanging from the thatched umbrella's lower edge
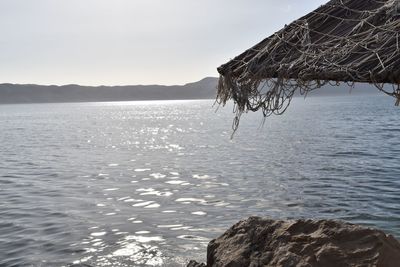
[[216, 73, 400, 137]]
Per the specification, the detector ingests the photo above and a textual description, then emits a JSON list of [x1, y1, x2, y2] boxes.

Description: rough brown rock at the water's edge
[[188, 217, 400, 267]]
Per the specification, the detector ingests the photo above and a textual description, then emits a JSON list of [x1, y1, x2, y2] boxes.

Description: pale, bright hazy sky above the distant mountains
[[0, 0, 327, 85]]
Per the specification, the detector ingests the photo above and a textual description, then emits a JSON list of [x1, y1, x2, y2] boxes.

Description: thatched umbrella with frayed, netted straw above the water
[[217, 0, 400, 130]]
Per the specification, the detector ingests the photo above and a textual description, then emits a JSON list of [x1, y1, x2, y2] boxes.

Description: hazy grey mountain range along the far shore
[[0, 77, 380, 104]]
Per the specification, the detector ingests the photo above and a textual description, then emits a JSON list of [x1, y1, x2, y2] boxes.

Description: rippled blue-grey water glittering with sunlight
[[0, 96, 400, 267]]
